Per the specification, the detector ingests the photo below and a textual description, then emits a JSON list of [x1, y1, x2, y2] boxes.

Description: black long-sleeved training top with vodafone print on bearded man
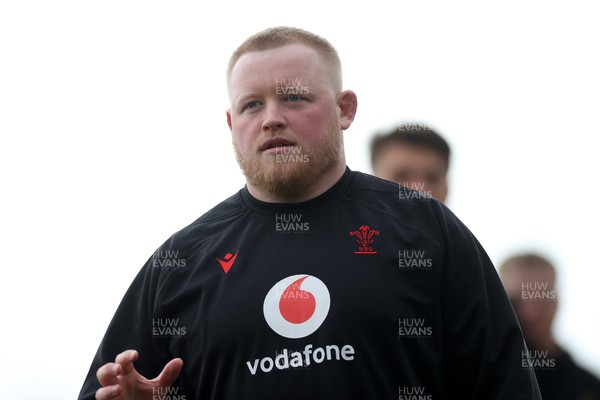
[[80, 169, 539, 400]]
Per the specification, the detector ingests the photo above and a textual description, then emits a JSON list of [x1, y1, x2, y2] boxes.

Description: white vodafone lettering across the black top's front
[[246, 344, 354, 375]]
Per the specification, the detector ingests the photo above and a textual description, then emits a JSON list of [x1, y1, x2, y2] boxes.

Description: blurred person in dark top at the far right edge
[[500, 253, 600, 400]]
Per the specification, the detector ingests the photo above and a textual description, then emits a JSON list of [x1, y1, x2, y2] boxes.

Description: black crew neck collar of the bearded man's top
[[240, 166, 354, 215]]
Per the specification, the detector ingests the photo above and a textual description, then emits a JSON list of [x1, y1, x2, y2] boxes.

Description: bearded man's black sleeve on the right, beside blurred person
[[440, 206, 541, 400]]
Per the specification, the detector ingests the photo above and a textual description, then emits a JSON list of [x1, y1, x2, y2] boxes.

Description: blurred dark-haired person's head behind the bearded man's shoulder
[[371, 123, 450, 202]]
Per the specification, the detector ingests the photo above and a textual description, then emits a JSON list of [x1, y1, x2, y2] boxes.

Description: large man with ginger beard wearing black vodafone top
[[80, 27, 539, 400]]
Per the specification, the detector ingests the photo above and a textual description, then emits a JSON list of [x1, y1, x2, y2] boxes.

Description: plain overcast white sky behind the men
[[0, 0, 600, 400]]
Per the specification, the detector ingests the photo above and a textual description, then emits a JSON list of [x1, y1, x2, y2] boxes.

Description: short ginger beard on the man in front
[[233, 120, 343, 199]]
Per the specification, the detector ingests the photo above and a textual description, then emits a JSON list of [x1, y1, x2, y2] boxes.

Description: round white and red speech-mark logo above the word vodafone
[[263, 274, 331, 339]]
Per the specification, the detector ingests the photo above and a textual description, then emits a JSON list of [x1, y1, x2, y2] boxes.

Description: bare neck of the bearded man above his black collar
[[246, 161, 346, 203]]
